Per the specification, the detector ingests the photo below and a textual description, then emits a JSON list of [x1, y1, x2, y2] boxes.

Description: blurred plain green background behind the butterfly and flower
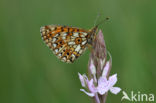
[[0, 0, 156, 103]]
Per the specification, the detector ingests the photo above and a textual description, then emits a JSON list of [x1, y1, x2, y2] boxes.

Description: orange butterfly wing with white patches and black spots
[[40, 25, 88, 63]]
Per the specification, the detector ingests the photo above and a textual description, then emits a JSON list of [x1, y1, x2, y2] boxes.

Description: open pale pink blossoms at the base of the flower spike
[[78, 61, 121, 97]]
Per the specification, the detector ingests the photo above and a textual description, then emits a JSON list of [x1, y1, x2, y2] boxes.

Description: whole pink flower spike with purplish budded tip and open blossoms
[[78, 30, 121, 103]]
